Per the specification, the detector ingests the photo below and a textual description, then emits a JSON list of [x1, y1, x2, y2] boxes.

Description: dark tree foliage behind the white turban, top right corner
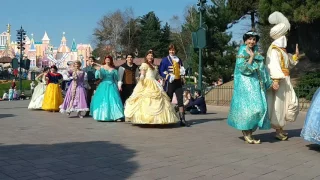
[[259, 0, 320, 62]]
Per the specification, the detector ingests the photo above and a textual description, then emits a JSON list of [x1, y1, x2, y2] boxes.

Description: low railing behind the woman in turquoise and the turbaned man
[[198, 86, 317, 111]]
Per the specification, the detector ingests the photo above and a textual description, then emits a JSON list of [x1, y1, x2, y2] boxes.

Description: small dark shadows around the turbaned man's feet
[[239, 129, 301, 143]]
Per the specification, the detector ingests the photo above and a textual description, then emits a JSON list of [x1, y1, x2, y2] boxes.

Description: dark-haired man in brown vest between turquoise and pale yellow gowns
[[118, 54, 139, 104]]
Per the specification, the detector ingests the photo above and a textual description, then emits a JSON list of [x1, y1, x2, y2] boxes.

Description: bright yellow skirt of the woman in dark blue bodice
[[42, 83, 63, 111]]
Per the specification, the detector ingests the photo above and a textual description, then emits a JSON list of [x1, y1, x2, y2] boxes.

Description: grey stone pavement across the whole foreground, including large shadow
[[0, 101, 320, 180]]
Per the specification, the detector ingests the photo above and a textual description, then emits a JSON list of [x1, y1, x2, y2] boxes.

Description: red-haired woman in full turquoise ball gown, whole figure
[[90, 56, 124, 121]]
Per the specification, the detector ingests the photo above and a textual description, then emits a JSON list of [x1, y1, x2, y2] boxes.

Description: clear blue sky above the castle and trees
[[0, 0, 250, 47]]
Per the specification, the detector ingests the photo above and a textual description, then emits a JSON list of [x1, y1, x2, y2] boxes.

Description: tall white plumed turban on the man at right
[[268, 11, 290, 39]]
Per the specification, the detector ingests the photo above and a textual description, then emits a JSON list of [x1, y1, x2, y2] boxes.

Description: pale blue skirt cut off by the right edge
[[301, 88, 320, 144]]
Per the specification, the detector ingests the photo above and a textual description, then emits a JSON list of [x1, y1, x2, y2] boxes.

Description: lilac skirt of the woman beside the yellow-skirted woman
[[60, 83, 89, 113]]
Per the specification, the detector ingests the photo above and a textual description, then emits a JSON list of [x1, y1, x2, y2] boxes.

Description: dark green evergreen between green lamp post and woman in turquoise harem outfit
[[203, 0, 237, 83]]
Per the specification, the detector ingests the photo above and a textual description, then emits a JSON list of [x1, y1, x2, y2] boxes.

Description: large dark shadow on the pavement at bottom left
[[0, 141, 139, 180]]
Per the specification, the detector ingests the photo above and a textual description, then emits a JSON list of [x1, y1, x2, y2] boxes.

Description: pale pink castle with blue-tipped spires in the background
[[0, 24, 92, 69]]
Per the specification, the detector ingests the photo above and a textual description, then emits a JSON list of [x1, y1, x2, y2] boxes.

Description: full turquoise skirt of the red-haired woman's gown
[[90, 81, 124, 121]]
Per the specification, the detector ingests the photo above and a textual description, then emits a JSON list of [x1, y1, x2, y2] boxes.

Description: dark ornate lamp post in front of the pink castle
[[17, 26, 27, 93]]
